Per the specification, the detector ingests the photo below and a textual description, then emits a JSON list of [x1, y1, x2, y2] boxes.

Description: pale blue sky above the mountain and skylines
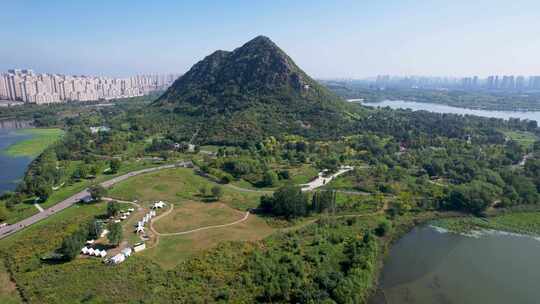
[[0, 0, 540, 78]]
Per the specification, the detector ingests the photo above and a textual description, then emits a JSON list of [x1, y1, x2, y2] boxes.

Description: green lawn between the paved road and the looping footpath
[[109, 168, 261, 210]]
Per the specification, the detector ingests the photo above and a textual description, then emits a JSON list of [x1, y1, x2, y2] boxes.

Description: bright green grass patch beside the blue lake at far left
[[4, 129, 64, 157]]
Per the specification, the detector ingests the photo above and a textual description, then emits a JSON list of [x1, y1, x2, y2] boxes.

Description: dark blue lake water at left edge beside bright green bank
[[0, 128, 32, 193]]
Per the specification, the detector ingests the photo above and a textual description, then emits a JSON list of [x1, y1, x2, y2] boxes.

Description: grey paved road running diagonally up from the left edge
[[0, 162, 189, 239]]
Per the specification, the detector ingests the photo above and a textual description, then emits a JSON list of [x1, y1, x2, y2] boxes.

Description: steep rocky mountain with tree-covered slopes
[[152, 36, 360, 143]]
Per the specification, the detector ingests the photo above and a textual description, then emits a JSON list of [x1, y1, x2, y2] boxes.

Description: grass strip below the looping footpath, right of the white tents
[[142, 215, 274, 269]]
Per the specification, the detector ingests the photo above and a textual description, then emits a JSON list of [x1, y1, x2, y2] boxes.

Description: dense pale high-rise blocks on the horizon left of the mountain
[[0, 70, 179, 104]]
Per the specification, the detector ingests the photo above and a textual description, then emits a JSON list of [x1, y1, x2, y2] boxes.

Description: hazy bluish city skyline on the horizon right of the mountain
[[367, 75, 540, 92]]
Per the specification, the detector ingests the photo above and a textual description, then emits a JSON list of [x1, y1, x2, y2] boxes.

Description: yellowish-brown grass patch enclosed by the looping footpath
[[154, 201, 244, 233]]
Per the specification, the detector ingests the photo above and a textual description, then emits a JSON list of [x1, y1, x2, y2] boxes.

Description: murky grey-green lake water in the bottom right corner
[[371, 226, 540, 304]]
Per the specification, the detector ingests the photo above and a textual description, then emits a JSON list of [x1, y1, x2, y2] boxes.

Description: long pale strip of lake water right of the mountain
[[363, 100, 540, 123]]
